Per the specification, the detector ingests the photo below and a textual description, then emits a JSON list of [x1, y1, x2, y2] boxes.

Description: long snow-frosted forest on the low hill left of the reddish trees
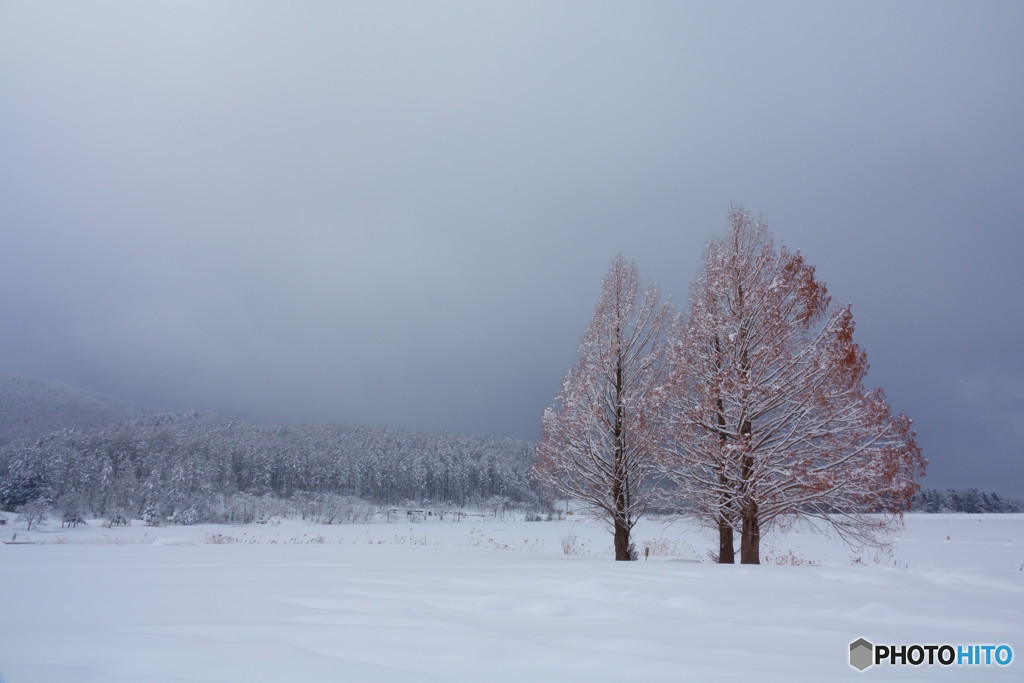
[[0, 413, 536, 523]]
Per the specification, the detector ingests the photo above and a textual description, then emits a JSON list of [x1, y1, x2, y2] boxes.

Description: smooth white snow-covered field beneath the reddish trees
[[0, 515, 1024, 683]]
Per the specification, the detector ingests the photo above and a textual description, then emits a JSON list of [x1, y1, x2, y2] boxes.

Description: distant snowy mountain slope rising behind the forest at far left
[[0, 375, 158, 445]]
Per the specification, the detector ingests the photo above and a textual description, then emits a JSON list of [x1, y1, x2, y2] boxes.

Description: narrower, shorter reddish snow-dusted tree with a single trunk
[[534, 256, 674, 560]]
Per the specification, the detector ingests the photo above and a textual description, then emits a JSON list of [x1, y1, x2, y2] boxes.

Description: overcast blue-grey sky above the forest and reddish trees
[[0, 0, 1024, 495]]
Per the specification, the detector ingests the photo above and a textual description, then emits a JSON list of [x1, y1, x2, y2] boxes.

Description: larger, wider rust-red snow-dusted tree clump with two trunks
[[660, 207, 927, 564]]
